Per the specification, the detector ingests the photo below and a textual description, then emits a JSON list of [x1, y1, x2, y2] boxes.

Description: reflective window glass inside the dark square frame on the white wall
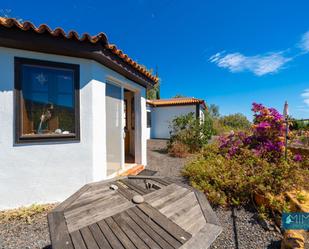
[[20, 64, 76, 136]]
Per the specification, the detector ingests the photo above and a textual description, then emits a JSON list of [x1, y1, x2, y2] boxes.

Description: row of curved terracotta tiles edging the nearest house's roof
[[0, 17, 158, 83]]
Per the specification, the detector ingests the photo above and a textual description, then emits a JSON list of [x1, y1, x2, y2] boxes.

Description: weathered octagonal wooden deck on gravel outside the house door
[[48, 176, 222, 249]]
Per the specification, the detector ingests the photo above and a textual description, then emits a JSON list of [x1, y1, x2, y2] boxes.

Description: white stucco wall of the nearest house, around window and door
[[0, 47, 147, 209]]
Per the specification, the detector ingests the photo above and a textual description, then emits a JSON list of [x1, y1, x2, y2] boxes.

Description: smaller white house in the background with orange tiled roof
[[147, 98, 206, 139]]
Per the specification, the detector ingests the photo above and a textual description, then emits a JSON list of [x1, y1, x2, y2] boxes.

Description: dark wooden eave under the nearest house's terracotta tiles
[[0, 26, 157, 87]]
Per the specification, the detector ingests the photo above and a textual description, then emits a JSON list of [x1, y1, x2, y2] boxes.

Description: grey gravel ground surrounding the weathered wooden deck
[[0, 140, 281, 249]]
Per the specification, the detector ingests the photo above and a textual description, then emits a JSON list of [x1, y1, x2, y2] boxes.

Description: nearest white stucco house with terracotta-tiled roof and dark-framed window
[[0, 18, 158, 209]]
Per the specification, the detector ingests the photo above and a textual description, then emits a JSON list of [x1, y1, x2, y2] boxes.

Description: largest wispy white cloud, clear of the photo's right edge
[[209, 51, 292, 76]]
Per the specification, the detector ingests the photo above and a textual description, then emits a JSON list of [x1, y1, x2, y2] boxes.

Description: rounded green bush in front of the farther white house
[[167, 113, 213, 155]]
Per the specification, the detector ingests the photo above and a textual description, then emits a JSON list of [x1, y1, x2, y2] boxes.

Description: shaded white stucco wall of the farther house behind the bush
[[150, 105, 196, 139]]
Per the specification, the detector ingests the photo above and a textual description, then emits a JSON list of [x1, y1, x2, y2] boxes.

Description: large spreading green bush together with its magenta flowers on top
[[183, 103, 309, 207]]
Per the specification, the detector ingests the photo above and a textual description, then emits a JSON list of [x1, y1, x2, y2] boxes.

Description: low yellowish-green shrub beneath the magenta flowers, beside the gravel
[[183, 144, 308, 205]]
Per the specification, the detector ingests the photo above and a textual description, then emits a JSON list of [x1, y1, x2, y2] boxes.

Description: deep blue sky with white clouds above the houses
[[0, 0, 309, 118]]
